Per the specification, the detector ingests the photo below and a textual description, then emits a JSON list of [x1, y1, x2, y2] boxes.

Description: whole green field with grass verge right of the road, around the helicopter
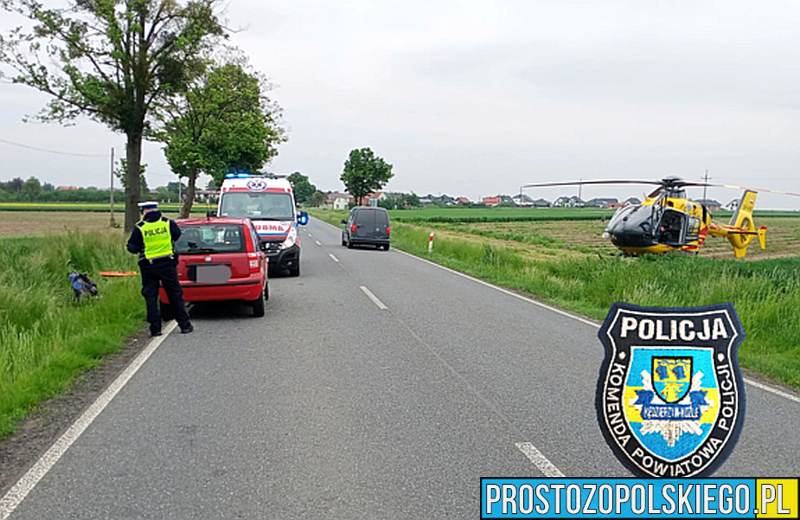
[[312, 209, 800, 388]]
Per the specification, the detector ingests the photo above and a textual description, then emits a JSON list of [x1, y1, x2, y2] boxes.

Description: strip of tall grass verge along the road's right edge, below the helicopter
[[311, 210, 800, 388]]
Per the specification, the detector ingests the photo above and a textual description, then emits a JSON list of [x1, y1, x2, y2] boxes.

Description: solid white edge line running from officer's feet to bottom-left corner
[[0, 321, 178, 520]]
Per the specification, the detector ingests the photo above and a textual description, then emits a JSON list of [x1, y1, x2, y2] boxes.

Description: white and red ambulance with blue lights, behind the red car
[[217, 173, 308, 276]]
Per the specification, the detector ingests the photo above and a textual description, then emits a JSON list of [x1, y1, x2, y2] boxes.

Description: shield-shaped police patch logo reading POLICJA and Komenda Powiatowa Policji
[[596, 303, 745, 478]]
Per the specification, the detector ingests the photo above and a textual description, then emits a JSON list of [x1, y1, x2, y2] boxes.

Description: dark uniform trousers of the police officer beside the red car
[[139, 259, 191, 333]]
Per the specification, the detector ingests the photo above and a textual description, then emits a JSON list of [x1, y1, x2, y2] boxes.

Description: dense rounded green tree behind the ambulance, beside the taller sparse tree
[[157, 52, 286, 218]]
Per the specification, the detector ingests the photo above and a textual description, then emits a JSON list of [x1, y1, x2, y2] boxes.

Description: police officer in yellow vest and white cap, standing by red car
[[128, 202, 194, 336]]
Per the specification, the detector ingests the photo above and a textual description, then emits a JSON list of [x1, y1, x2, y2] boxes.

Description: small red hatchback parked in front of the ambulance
[[159, 217, 269, 319]]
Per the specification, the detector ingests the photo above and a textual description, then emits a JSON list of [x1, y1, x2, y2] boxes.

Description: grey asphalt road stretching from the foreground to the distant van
[[6, 220, 800, 520]]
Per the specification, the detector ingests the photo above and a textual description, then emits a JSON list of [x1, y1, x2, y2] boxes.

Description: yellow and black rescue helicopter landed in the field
[[522, 176, 800, 258]]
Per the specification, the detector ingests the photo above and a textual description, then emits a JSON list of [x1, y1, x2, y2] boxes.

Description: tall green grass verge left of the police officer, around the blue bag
[[0, 231, 144, 438]]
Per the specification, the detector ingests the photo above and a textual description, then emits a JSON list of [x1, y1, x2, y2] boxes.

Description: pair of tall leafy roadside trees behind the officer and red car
[[0, 0, 286, 231]]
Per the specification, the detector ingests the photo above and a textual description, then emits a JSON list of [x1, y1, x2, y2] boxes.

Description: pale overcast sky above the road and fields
[[0, 0, 800, 209]]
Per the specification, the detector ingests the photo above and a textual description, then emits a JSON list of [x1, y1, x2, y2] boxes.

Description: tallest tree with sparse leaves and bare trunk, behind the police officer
[[0, 0, 224, 231]]
